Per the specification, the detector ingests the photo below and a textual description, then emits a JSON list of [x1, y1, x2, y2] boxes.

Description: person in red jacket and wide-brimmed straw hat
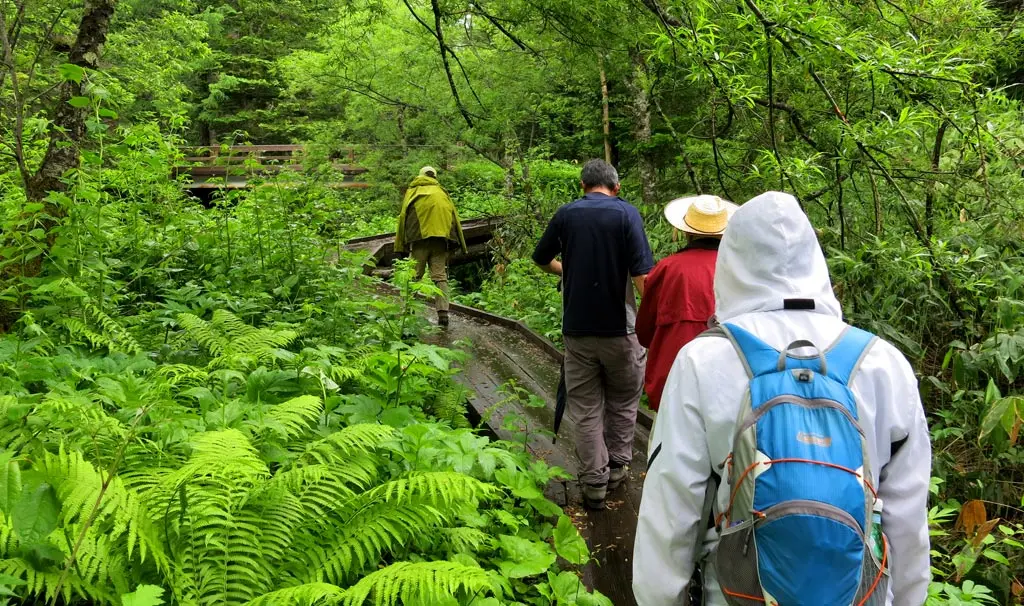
[[636, 196, 738, 410]]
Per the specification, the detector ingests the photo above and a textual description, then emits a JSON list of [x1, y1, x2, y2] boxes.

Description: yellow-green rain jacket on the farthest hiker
[[394, 175, 466, 253]]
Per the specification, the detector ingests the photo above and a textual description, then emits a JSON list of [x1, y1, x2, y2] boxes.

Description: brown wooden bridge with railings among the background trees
[[172, 145, 370, 193]]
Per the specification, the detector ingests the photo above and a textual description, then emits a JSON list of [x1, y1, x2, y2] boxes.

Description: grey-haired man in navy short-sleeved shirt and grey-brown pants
[[534, 160, 654, 509]]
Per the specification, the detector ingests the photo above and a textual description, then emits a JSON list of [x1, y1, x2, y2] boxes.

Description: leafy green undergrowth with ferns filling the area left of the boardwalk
[[0, 131, 610, 606]]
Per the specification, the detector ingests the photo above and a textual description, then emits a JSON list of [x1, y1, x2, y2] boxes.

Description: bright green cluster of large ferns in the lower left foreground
[[0, 388, 516, 605]]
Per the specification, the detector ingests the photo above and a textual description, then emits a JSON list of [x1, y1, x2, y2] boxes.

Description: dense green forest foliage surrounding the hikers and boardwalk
[[0, 0, 1024, 605]]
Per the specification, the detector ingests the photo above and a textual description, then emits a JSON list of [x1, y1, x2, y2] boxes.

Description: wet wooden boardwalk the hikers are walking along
[[345, 225, 653, 606]]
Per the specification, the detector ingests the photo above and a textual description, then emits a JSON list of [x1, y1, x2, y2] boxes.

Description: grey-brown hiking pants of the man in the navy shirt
[[564, 335, 646, 484]]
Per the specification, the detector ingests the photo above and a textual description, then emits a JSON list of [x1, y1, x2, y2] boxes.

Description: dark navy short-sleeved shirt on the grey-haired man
[[534, 192, 654, 337]]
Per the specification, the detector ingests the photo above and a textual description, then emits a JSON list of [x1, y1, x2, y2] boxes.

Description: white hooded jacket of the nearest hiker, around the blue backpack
[[633, 191, 932, 606]]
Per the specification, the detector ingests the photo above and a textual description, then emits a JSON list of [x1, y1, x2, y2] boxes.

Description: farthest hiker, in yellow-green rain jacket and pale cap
[[394, 166, 466, 327]]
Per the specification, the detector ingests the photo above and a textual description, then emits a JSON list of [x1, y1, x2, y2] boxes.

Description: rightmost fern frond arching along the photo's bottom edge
[[342, 562, 490, 606]]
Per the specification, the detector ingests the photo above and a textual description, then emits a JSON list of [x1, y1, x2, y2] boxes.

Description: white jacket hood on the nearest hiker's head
[[715, 191, 843, 322]]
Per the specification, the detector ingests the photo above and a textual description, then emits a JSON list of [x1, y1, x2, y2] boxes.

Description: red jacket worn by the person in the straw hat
[[637, 239, 720, 410]]
